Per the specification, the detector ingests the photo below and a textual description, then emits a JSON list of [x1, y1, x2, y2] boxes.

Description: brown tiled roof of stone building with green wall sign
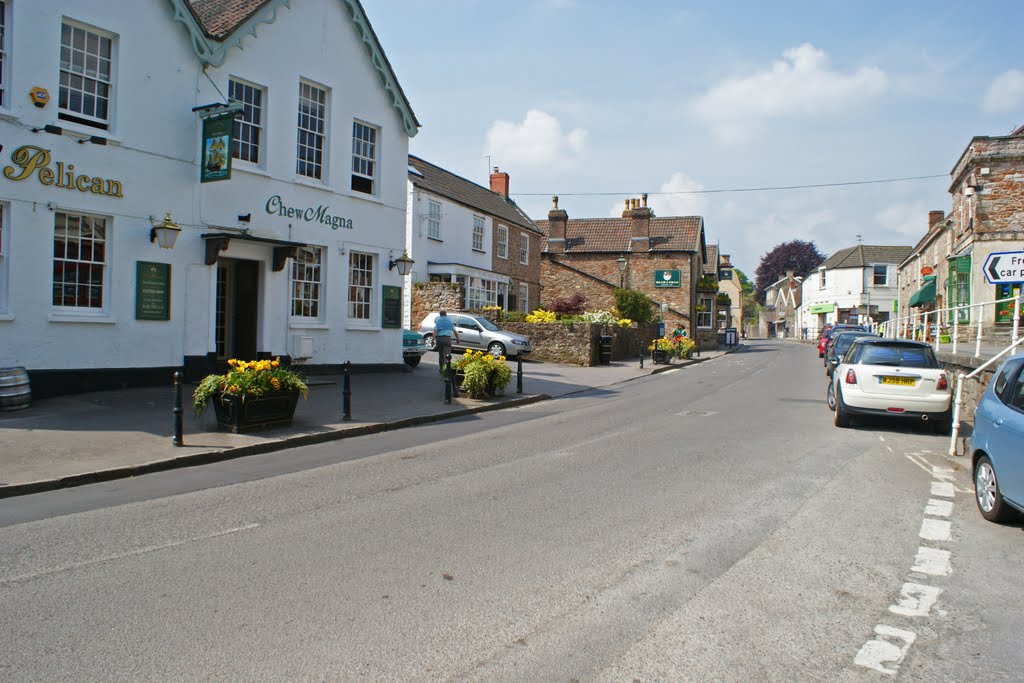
[[535, 216, 703, 253]]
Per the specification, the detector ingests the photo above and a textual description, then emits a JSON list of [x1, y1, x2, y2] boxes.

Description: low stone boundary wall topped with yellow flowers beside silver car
[[499, 322, 657, 368]]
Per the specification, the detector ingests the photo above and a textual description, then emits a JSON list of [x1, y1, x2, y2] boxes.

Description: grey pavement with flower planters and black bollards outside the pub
[[0, 346, 742, 498]]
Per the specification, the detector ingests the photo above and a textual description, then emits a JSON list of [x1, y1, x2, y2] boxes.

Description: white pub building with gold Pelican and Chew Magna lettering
[[0, 0, 419, 396]]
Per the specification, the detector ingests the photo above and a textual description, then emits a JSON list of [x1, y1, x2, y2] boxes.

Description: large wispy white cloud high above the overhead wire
[[691, 43, 887, 142]]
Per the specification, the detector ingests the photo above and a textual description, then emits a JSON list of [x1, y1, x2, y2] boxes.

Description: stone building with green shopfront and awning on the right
[[899, 126, 1024, 331]]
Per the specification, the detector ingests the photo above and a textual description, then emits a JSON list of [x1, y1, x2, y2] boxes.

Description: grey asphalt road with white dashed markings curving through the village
[[0, 342, 1024, 681]]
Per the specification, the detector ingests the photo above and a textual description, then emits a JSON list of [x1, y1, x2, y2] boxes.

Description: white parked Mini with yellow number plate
[[826, 336, 952, 434]]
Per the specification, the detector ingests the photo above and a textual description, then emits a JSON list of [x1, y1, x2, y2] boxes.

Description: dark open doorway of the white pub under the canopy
[[214, 258, 260, 360]]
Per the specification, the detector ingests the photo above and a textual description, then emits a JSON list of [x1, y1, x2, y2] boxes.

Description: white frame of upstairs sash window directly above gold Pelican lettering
[[57, 17, 117, 131]]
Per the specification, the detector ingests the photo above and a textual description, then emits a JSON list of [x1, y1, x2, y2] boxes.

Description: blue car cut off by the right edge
[[970, 355, 1024, 522]]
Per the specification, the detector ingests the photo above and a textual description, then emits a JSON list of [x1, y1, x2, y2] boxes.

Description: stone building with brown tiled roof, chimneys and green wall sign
[[536, 195, 718, 347]]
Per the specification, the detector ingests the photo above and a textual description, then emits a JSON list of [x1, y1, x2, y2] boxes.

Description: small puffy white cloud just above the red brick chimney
[[484, 110, 587, 166]]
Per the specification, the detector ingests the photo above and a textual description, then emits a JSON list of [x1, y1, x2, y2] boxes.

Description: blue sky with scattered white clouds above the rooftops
[[364, 0, 1024, 276]]
